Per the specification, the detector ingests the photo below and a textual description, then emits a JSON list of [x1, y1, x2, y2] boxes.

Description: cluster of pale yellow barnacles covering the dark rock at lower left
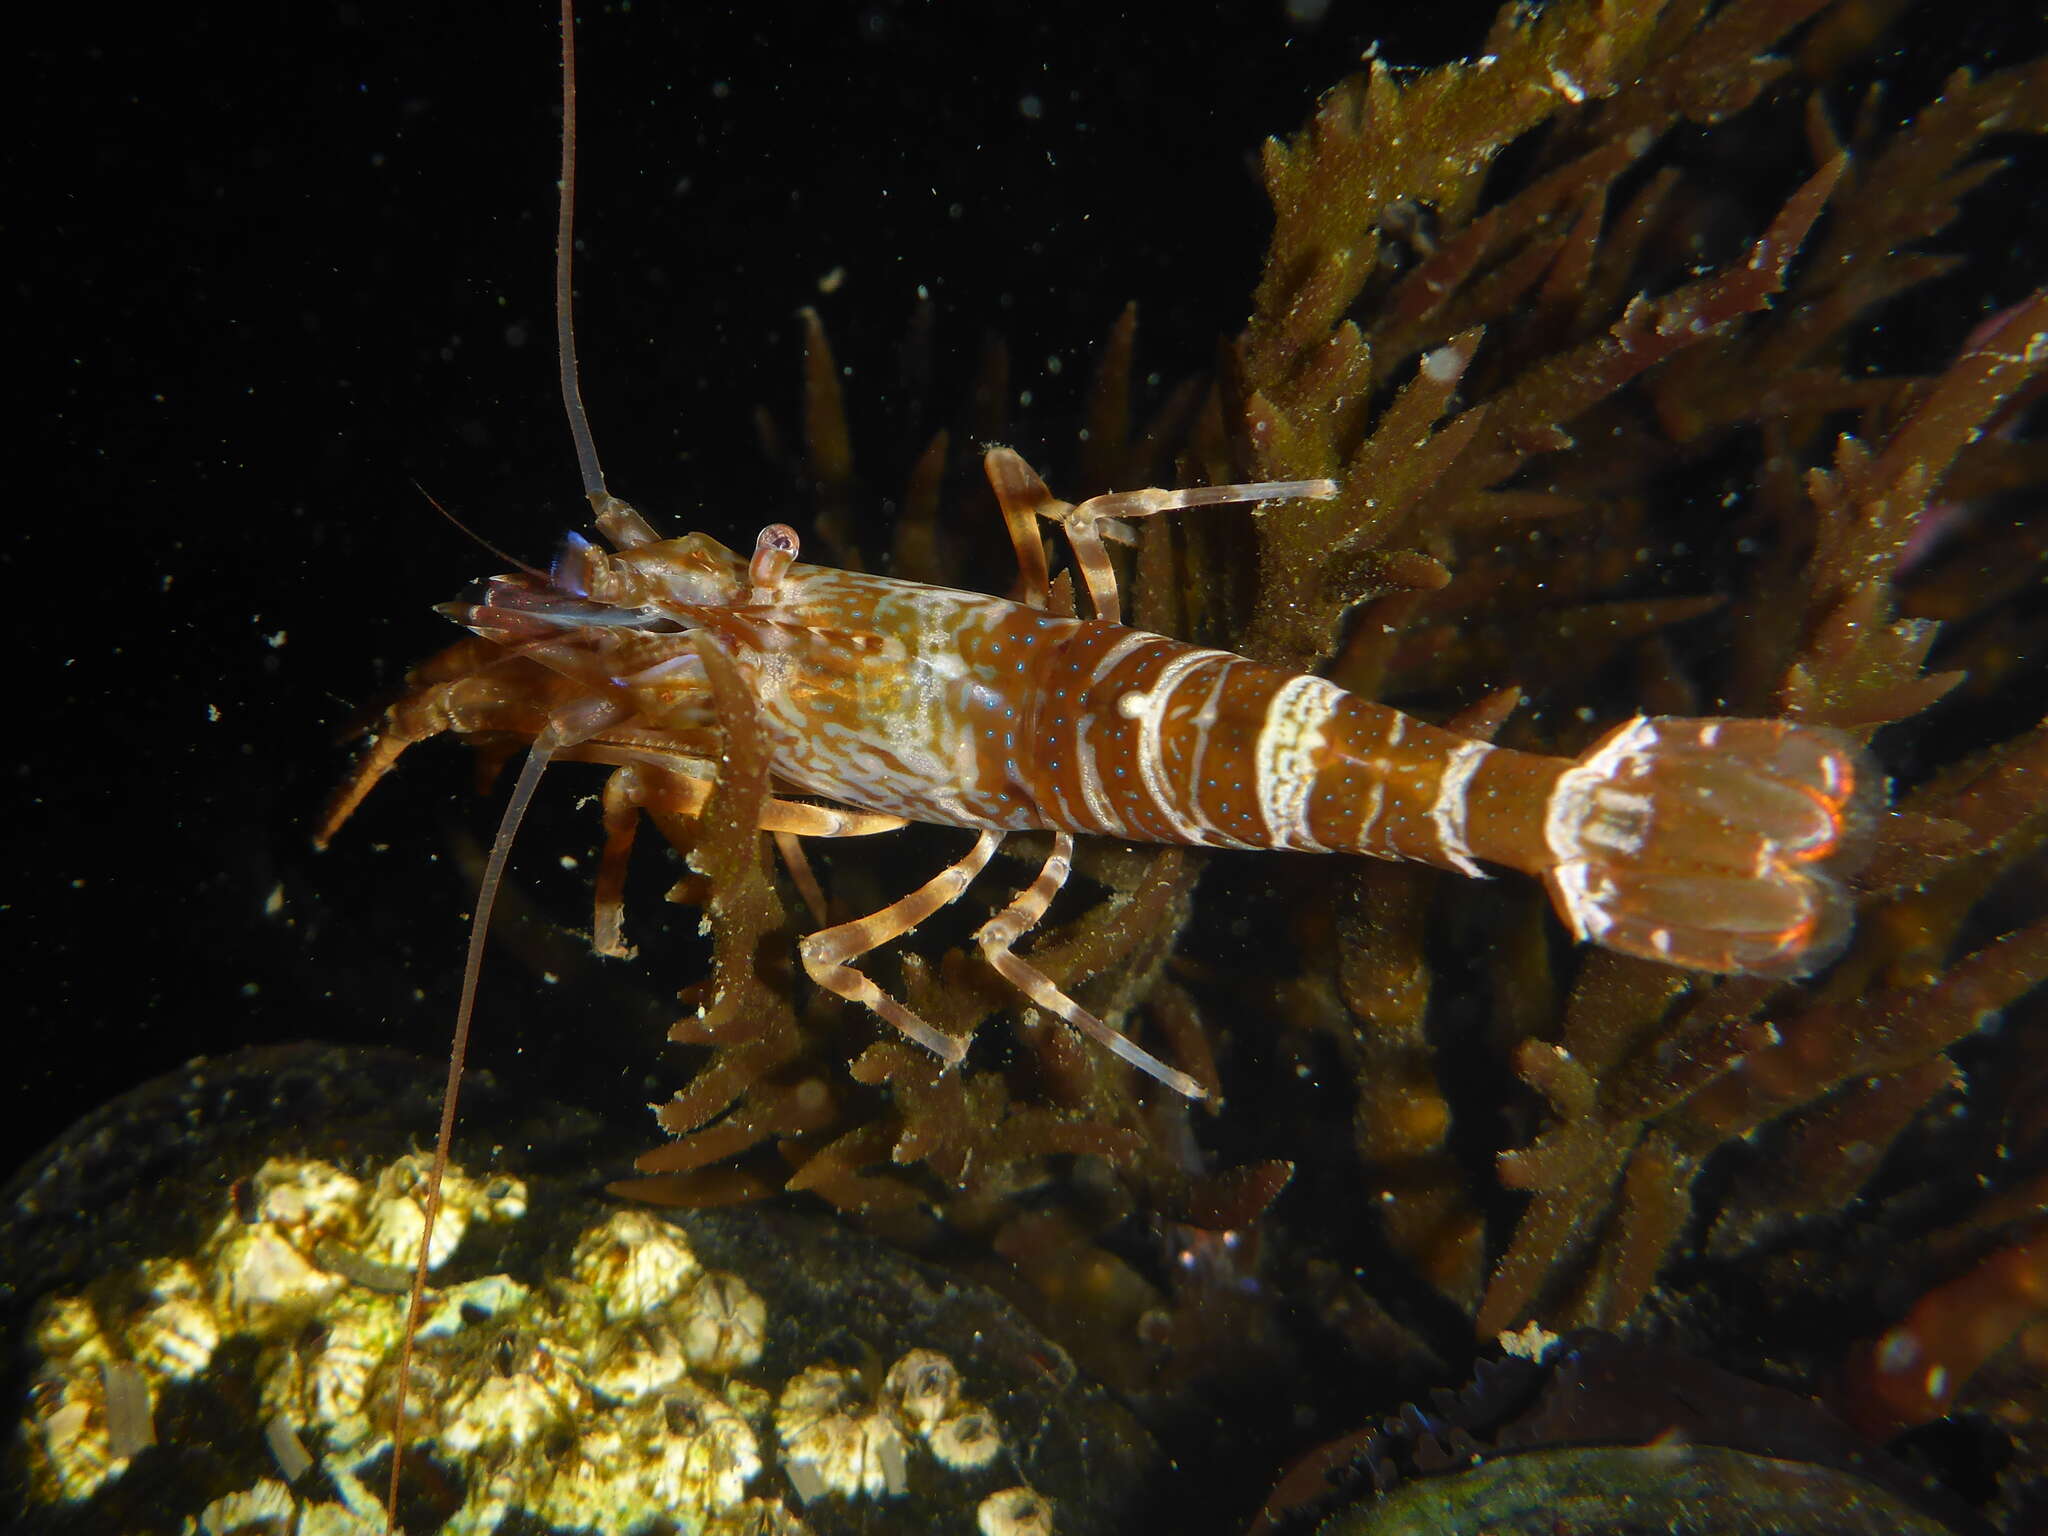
[[23, 1163, 1089, 1536]]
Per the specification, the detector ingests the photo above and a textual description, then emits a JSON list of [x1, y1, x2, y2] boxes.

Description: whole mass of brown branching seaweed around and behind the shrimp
[[520, 0, 2048, 1482]]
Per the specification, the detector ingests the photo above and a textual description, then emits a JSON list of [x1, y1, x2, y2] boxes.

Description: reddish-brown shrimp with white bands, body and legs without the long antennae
[[317, 449, 1884, 1094]]
